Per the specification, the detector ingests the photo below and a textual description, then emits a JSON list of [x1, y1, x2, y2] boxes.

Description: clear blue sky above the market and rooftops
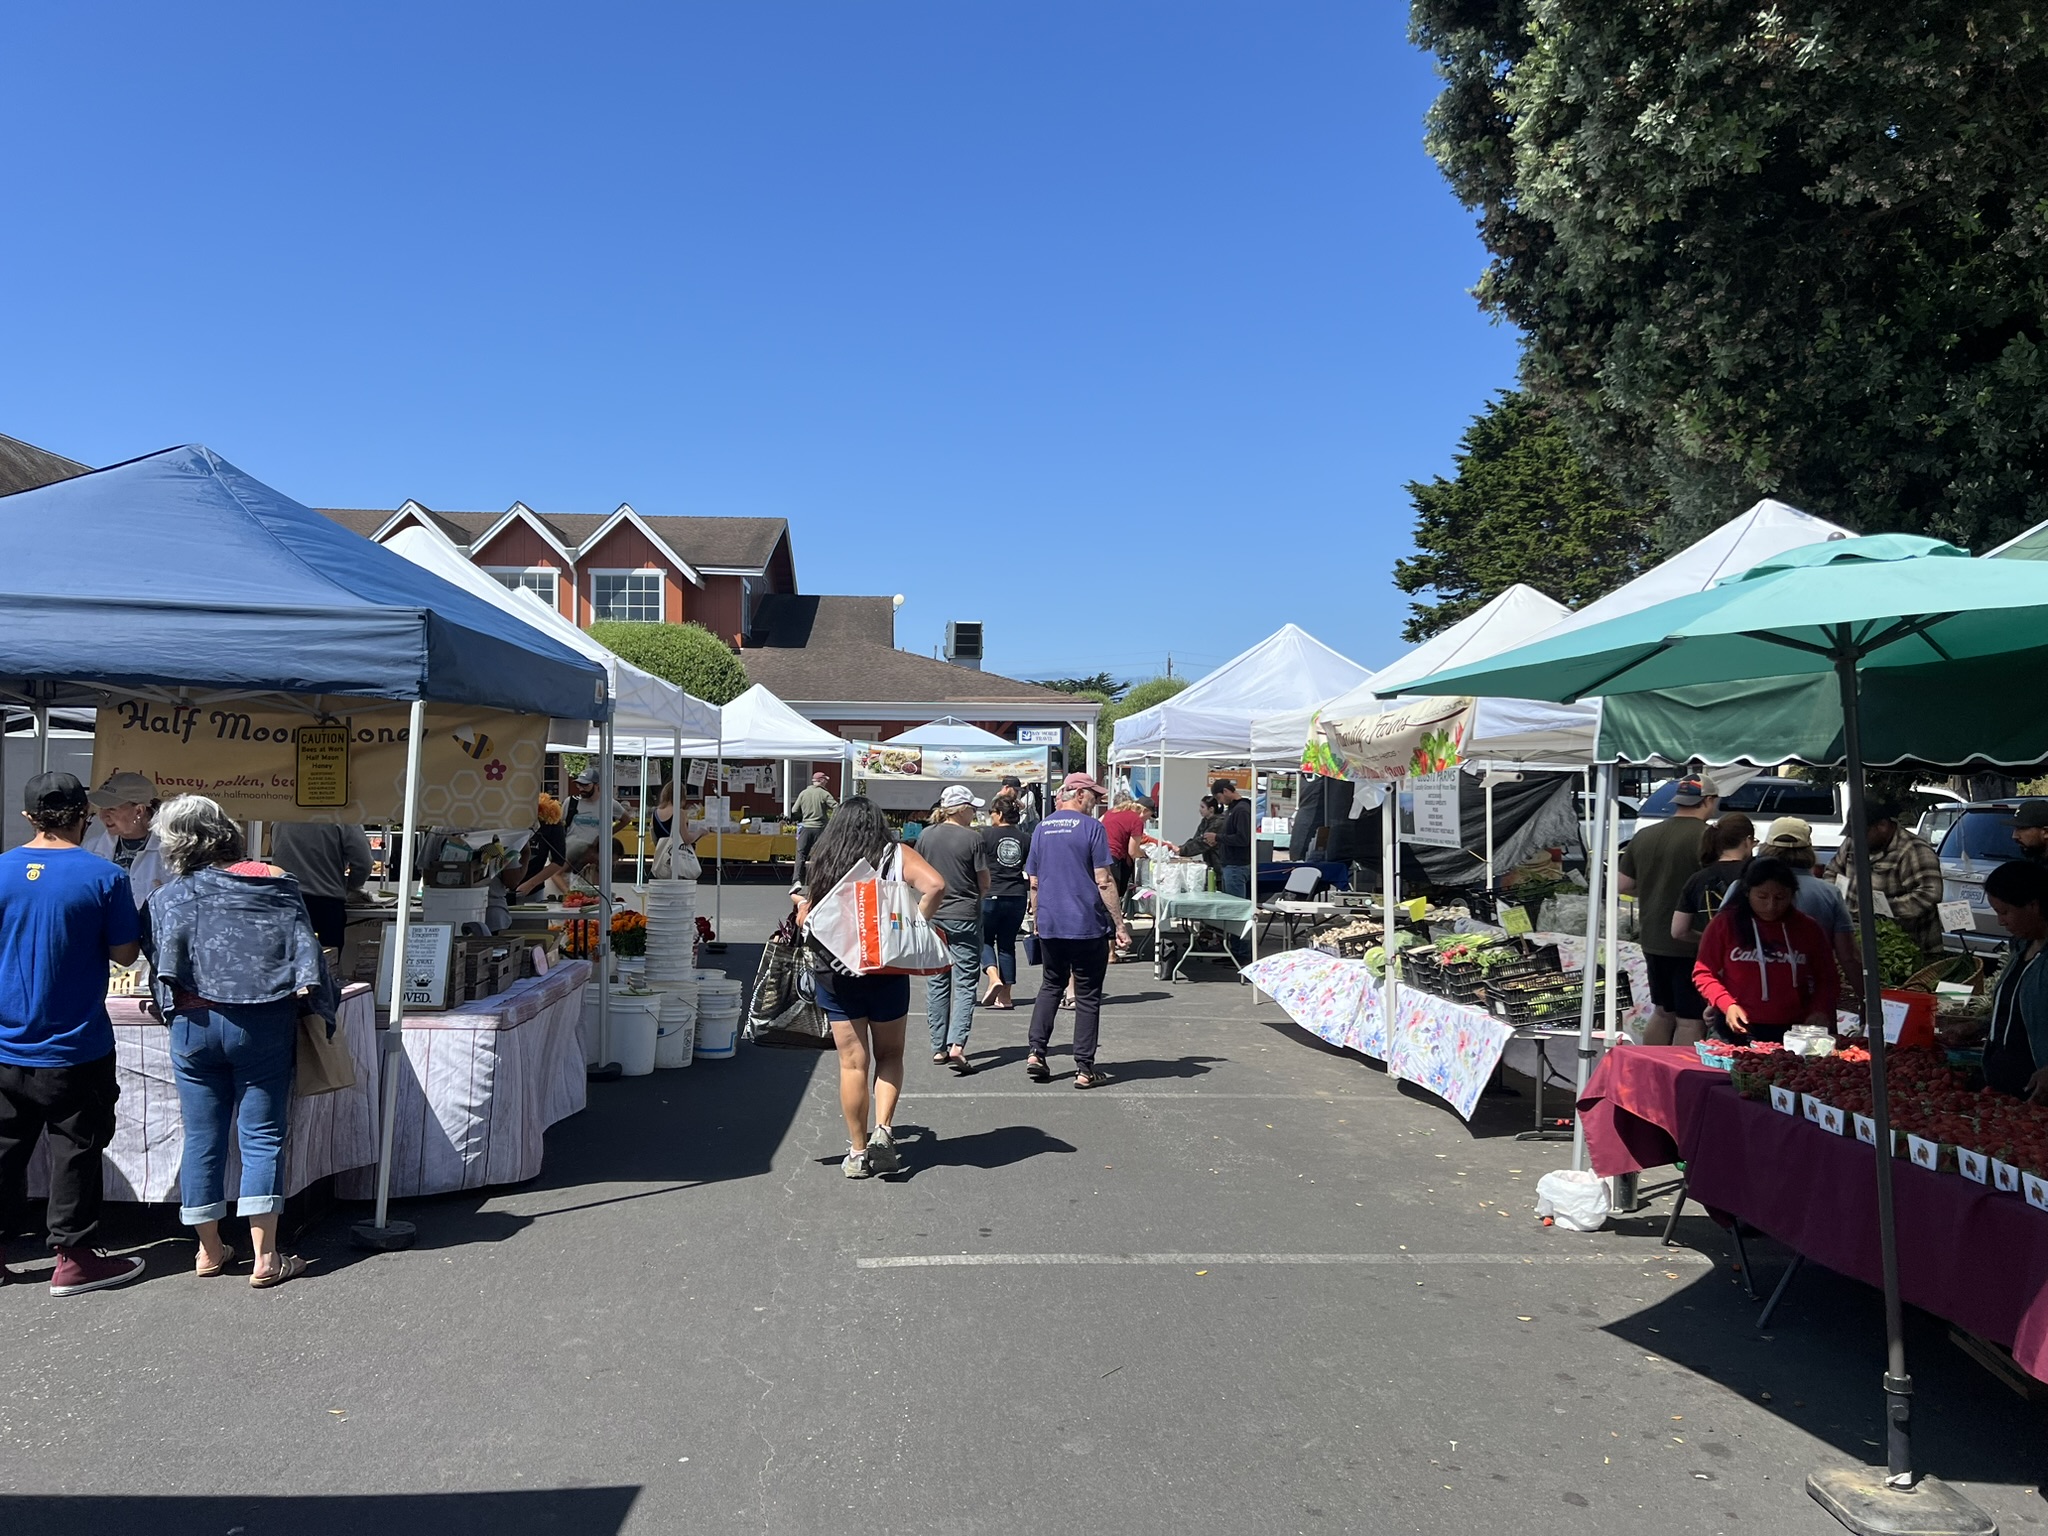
[[0, 0, 1516, 692]]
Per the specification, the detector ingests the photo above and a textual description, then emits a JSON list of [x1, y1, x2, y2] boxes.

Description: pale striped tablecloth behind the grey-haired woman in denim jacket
[[29, 985, 377, 1202]]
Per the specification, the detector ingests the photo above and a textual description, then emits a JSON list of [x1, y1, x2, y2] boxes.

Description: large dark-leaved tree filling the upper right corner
[[1413, 0, 2048, 549]]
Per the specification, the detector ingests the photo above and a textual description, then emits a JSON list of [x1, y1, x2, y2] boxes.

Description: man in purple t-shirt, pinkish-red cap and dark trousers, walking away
[[1024, 774, 1130, 1087]]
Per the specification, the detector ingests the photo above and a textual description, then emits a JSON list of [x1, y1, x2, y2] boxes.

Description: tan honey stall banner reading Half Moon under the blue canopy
[[92, 694, 549, 827]]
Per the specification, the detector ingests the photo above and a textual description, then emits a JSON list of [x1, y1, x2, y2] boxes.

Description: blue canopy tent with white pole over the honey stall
[[0, 444, 610, 1245]]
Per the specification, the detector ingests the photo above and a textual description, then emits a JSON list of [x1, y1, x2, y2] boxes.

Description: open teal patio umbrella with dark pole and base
[[1397, 535, 2048, 1532]]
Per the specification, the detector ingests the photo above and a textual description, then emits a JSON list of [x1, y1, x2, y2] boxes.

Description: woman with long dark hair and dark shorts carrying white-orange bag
[[797, 795, 946, 1180]]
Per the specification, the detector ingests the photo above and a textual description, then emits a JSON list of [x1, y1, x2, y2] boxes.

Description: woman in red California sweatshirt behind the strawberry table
[[1692, 858, 1841, 1040]]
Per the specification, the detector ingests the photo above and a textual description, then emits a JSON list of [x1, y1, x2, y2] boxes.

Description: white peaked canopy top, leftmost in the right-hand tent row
[[1110, 625, 1372, 762]]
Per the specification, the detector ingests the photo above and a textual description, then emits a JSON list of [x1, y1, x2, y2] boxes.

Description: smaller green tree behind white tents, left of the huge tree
[[1395, 391, 1655, 643]]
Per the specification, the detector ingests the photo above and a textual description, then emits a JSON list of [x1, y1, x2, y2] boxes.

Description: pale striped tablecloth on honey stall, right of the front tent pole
[[338, 961, 592, 1200]]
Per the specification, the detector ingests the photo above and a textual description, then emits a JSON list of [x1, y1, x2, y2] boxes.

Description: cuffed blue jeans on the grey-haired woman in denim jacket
[[170, 997, 299, 1227]]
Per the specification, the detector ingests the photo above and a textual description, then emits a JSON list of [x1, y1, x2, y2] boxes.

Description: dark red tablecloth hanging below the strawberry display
[[1581, 1047, 2048, 1380]]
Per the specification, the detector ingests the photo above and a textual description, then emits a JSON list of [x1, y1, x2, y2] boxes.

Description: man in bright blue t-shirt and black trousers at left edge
[[0, 774, 143, 1296]]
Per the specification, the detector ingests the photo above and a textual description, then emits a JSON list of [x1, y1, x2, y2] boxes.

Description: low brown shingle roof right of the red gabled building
[[739, 594, 1073, 709]]
